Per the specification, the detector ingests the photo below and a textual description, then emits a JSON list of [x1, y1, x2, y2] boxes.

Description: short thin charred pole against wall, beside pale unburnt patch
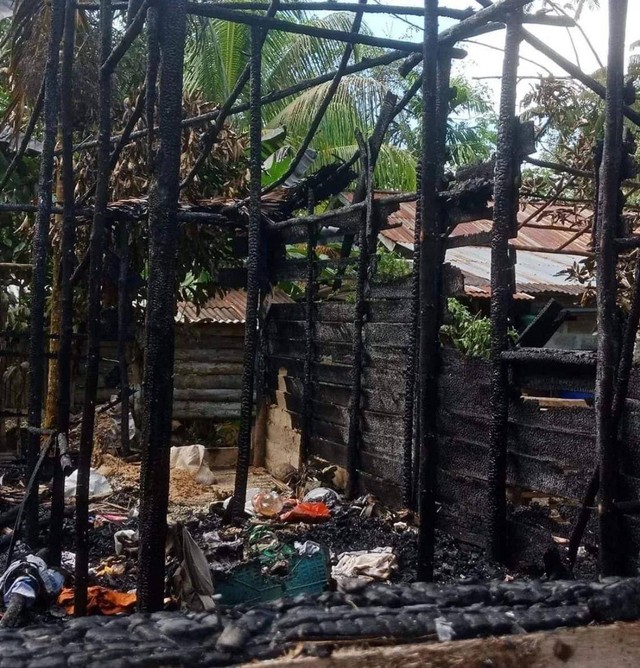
[[300, 201, 318, 466]]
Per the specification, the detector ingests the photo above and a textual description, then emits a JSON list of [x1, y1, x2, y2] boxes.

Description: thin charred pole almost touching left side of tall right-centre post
[[402, 164, 424, 508]]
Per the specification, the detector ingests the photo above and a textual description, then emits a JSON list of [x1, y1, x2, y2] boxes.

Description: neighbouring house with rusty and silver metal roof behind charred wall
[[379, 202, 596, 350]]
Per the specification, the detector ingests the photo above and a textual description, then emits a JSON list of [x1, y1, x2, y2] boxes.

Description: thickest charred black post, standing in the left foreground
[[138, 0, 187, 612]]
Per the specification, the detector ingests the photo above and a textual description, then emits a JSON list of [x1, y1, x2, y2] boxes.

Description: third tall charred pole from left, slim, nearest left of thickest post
[[74, 0, 113, 616]]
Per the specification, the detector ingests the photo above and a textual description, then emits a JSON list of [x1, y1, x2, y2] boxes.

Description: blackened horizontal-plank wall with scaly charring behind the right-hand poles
[[265, 294, 640, 570]]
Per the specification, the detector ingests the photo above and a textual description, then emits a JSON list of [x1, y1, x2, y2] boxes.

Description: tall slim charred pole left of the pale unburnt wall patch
[[231, 26, 262, 517]]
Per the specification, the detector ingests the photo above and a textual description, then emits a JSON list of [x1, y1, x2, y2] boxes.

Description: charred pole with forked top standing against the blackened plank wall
[[346, 133, 373, 499]]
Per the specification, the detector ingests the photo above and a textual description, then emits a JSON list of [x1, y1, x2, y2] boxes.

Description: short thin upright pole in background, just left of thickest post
[[118, 222, 130, 457]]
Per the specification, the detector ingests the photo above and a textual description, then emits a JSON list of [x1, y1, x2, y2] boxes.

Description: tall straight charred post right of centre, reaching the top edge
[[417, 0, 442, 581]]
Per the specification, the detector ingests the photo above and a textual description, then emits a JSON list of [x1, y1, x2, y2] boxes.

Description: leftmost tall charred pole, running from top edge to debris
[[25, 0, 64, 547]]
